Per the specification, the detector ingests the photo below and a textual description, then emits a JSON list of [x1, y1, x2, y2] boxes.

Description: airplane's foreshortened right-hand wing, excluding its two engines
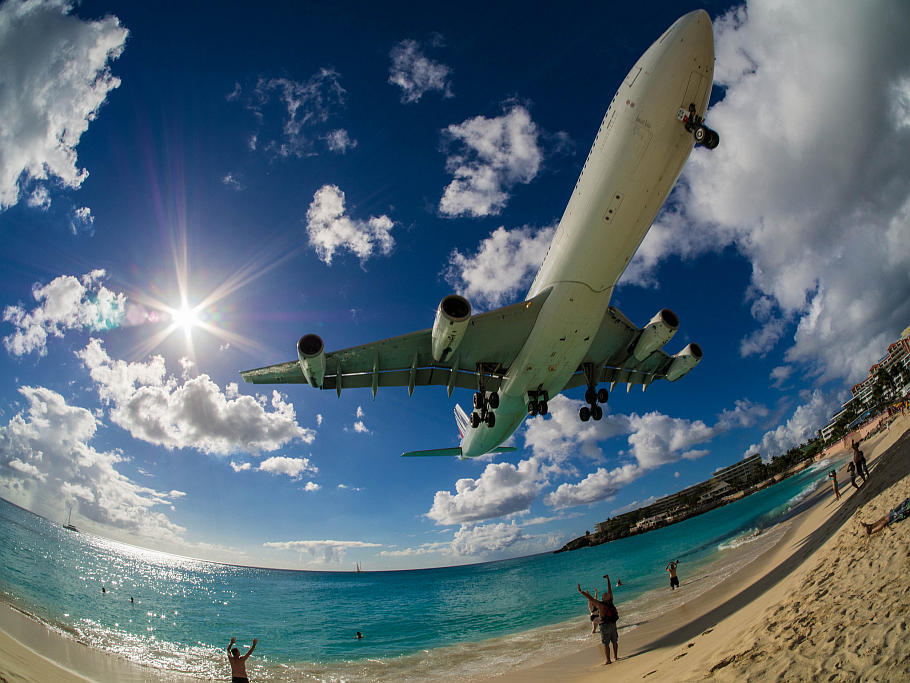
[[565, 306, 701, 389]]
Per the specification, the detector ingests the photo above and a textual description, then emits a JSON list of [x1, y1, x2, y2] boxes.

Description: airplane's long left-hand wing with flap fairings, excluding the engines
[[240, 290, 550, 396]]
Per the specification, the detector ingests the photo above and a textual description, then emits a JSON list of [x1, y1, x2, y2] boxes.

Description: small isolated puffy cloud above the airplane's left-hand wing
[[307, 185, 395, 265]]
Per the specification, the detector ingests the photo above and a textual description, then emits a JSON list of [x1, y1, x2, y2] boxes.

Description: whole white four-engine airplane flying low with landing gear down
[[241, 10, 720, 458]]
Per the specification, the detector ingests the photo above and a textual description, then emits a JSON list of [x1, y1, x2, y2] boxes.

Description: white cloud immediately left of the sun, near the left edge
[[3, 269, 126, 356]]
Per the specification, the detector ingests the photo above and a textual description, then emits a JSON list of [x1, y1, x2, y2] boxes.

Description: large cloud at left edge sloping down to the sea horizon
[[0, 386, 185, 542]]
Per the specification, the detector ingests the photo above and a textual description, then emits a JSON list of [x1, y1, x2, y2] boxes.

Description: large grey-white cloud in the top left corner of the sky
[[0, 0, 128, 210]]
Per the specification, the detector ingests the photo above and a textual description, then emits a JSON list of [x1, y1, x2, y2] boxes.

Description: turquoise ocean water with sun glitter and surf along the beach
[[0, 463, 840, 681]]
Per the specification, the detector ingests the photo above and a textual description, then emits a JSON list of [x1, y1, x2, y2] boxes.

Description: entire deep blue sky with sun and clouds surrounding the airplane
[[0, 0, 910, 571]]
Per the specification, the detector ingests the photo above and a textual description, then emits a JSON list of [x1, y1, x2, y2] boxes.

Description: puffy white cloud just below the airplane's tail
[[427, 459, 545, 524]]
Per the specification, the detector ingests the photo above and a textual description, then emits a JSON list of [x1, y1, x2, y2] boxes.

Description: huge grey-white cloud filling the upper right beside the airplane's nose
[[624, 0, 910, 383]]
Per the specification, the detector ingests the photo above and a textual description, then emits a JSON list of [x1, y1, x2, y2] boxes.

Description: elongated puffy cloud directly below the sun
[[76, 339, 316, 455]]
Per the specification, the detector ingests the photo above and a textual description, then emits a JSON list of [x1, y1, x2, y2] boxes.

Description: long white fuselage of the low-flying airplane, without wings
[[461, 10, 714, 457]]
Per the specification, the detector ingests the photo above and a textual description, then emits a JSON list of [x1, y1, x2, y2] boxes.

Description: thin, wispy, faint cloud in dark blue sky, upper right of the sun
[[237, 69, 353, 157]]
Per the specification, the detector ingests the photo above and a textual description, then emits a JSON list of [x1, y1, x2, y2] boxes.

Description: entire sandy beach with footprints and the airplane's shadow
[[0, 408, 910, 683]]
